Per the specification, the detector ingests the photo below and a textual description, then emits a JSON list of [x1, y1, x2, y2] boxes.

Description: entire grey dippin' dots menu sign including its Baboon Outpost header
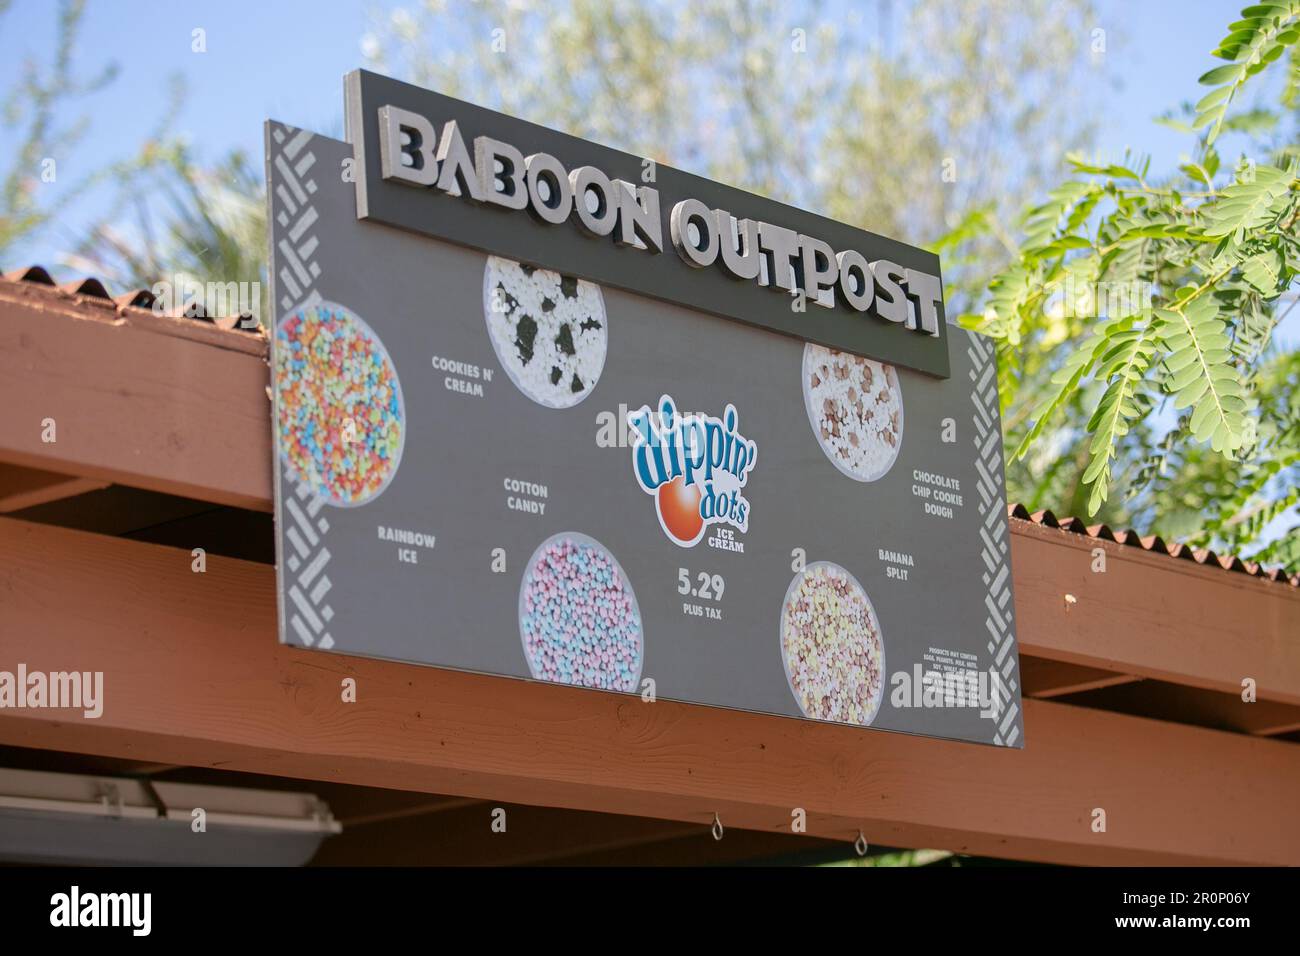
[[267, 73, 1023, 747]]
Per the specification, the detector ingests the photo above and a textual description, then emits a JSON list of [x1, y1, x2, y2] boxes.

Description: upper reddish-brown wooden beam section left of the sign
[[0, 284, 272, 511]]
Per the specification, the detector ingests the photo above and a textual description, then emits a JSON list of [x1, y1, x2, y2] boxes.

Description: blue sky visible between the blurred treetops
[[0, 0, 1258, 268]]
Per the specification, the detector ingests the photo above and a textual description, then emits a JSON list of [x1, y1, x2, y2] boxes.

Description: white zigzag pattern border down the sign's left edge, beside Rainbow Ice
[[270, 126, 334, 650]]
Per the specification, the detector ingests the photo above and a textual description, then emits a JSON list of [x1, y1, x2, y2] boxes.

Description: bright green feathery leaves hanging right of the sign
[[962, 0, 1300, 559]]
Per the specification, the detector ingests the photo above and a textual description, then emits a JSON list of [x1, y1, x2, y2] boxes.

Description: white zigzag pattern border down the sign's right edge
[[966, 333, 1021, 747]]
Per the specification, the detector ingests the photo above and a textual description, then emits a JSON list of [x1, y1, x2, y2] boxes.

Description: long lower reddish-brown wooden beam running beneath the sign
[[0, 519, 1300, 864]]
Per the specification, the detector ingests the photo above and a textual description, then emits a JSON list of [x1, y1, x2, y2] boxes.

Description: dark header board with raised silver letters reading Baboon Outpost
[[346, 70, 948, 377]]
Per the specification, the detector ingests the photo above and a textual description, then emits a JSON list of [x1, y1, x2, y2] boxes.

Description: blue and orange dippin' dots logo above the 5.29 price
[[628, 395, 758, 548]]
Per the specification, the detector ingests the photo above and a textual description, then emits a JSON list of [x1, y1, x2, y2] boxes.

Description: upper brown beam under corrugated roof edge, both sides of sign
[[0, 291, 1300, 705]]
